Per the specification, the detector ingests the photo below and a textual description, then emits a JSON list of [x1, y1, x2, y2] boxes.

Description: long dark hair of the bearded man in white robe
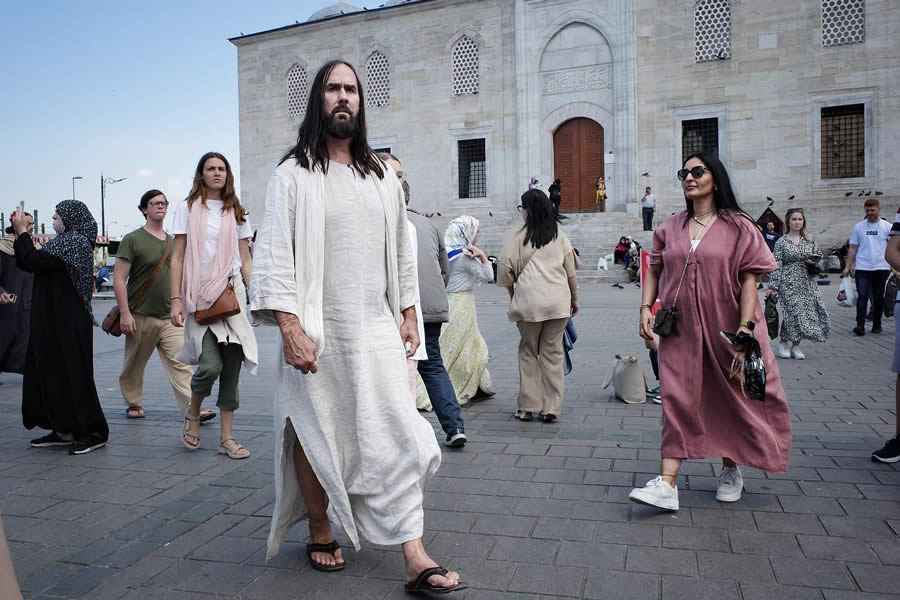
[[278, 60, 384, 179]]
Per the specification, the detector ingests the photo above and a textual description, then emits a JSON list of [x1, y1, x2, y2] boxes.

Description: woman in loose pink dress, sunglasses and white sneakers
[[629, 154, 791, 510]]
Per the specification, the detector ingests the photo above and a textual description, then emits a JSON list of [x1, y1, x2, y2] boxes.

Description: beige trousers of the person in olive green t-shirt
[[119, 315, 194, 413]]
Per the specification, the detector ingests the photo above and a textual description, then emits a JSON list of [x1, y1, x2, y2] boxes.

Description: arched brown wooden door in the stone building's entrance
[[553, 118, 603, 212]]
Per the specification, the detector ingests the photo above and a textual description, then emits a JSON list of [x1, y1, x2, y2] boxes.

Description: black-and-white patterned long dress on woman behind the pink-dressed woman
[[769, 235, 831, 342]]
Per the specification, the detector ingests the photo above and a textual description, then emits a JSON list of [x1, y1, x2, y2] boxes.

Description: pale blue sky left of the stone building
[[0, 0, 338, 237]]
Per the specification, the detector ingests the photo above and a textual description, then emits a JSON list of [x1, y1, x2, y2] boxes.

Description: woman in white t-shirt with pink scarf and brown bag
[[170, 152, 257, 459]]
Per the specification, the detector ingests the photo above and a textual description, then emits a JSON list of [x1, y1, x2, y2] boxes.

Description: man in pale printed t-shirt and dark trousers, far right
[[843, 198, 891, 335]]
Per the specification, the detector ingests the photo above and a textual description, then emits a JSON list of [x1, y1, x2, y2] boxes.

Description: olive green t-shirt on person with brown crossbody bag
[[116, 227, 175, 319]]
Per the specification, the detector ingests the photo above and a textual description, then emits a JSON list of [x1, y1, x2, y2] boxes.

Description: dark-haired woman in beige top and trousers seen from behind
[[497, 189, 578, 423]]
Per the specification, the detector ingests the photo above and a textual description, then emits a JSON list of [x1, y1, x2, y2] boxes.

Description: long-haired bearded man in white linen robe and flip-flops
[[251, 61, 466, 591]]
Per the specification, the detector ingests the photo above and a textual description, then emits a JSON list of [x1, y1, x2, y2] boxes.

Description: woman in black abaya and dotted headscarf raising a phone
[[12, 200, 109, 454]]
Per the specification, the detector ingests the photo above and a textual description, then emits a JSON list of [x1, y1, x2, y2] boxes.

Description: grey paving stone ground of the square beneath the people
[[0, 284, 900, 600]]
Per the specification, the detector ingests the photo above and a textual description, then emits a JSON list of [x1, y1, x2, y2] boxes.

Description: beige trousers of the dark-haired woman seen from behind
[[516, 319, 568, 416]]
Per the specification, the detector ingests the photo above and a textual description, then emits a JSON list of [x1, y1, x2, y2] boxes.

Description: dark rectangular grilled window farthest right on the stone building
[[821, 104, 866, 179]]
